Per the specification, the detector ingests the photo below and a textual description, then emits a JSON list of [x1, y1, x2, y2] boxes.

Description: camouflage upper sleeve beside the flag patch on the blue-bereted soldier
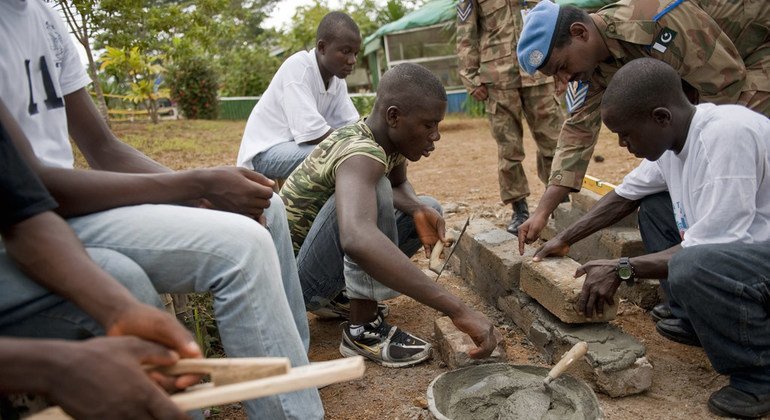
[[650, 3, 746, 104]]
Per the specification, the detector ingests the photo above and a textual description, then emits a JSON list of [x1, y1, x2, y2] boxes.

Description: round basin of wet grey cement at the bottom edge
[[428, 363, 602, 420]]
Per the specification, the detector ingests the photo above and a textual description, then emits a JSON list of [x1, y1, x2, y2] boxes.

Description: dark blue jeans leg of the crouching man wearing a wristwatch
[[668, 244, 770, 395]]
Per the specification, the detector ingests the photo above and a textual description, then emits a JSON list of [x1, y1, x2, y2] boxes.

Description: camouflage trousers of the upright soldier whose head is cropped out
[[486, 83, 564, 204]]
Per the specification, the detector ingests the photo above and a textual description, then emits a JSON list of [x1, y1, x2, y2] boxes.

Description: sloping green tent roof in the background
[[364, 0, 457, 55]]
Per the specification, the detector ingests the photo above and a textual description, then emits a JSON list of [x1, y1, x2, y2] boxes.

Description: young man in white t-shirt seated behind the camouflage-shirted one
[[237, 12, 361, 179]]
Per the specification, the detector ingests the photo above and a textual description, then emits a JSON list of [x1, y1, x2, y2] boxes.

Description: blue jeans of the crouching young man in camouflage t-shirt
[[297, 177, 441, 311]]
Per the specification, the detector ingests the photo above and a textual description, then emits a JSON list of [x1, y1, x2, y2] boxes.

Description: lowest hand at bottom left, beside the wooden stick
[[45, 337, 187, 419]]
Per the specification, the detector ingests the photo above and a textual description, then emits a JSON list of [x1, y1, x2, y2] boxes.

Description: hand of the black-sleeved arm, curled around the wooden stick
[[105, 303, 203, 391]]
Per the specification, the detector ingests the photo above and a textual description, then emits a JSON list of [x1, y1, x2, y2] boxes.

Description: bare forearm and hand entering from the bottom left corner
[[0, 337, 186, 419]]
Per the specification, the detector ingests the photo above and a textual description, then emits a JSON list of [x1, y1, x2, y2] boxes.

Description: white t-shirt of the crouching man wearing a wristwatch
[[615, 104, 770, 247]]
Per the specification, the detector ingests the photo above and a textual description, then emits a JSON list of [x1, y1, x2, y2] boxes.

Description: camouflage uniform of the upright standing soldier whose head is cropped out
[[457, 0, 564, 203]]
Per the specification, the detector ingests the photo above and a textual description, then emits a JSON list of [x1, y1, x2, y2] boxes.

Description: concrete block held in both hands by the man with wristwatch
[[519, 258, 618, 324]]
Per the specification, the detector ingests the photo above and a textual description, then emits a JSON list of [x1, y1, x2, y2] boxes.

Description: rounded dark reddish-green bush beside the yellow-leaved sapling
[[169, 57, 219, 120]]
